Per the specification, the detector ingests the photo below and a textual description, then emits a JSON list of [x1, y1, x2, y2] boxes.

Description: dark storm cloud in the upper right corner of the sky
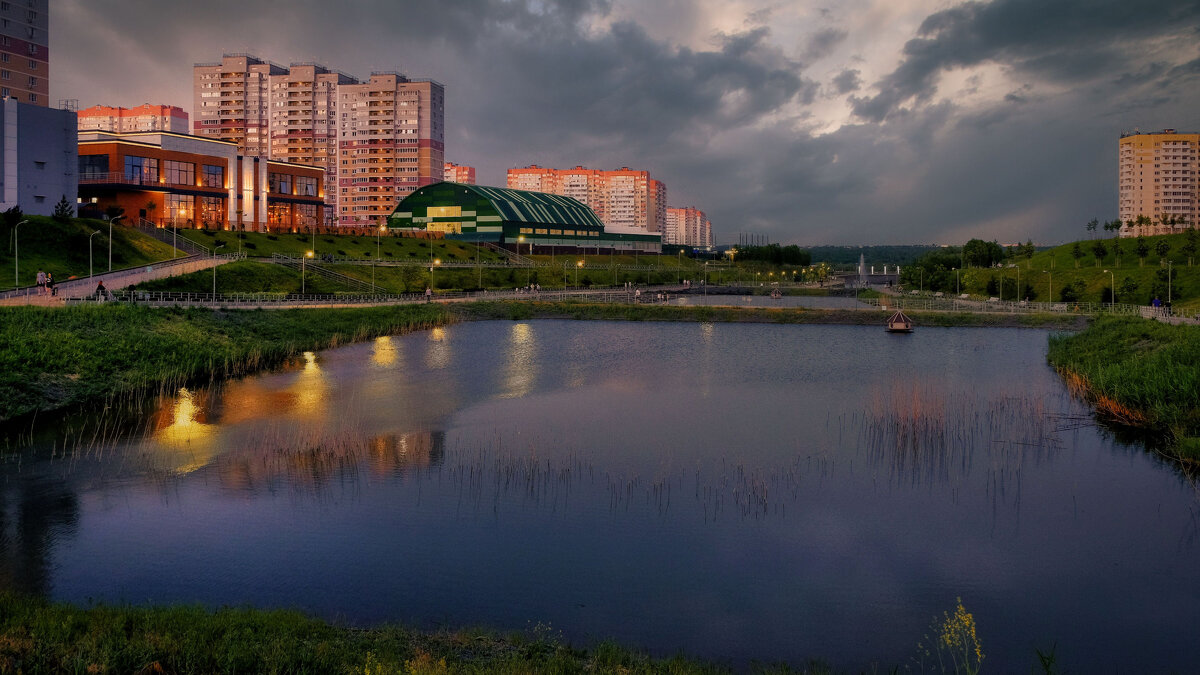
[[852, 0, 1200, 121]]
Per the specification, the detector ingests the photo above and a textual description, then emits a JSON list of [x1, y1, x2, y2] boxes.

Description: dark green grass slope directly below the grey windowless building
[[0, 216, 175, 291]]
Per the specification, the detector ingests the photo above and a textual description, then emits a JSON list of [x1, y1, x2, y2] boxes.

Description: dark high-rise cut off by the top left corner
[[0, 0, 50, 106]]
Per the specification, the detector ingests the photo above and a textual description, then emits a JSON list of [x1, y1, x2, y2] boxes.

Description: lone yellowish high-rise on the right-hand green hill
[[1117, 129, 1200, 237]]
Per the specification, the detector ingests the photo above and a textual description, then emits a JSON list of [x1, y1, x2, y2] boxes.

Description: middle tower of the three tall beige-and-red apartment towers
[[268, 64, 359, 222]]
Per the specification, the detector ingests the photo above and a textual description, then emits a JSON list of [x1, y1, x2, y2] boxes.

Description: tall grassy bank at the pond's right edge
[[1048, 317, 1200, 461]]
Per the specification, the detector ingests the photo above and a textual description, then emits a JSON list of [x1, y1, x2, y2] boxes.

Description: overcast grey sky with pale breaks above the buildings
[[50, 0, 1200, 245]]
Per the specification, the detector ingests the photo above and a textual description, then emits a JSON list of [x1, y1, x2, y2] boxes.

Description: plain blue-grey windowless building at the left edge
[[0, 97, 78, 215]]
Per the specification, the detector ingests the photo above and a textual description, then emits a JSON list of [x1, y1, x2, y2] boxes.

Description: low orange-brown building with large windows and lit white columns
[[78, 131, 324, 232]]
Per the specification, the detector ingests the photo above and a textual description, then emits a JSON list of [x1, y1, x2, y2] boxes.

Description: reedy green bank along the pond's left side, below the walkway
[[0, 304, 450, 422]]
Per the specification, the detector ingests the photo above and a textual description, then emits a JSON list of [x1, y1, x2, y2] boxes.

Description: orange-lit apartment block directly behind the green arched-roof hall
[[508, 165, 666, 232]]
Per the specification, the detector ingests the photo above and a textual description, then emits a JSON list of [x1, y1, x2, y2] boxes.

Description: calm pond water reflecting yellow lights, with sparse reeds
[[0, 321, 1200, 673]]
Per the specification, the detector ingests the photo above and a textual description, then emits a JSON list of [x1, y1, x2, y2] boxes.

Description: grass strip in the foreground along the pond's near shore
[[0, 593, 768, 675]]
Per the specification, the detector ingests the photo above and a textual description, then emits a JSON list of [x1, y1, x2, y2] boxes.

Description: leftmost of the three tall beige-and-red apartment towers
[[192, 54, 288, 157]]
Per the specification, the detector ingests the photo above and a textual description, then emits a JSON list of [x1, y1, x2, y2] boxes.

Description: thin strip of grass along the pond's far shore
[[450, 300, 1087, 330]]
